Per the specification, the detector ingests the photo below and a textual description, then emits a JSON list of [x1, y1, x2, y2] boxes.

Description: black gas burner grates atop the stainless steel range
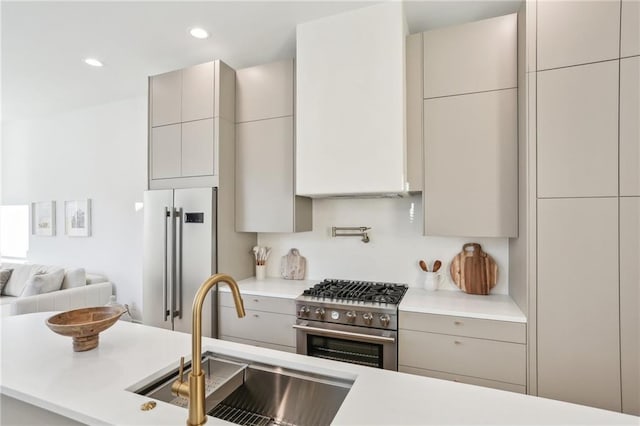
[[302, 279, 408, 304]]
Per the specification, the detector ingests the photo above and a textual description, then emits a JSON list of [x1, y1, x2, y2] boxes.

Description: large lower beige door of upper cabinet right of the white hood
[[424, 89, 518, 237]]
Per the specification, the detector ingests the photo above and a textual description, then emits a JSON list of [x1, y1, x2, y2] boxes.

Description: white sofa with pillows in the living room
[[0, 263, 113, 317]]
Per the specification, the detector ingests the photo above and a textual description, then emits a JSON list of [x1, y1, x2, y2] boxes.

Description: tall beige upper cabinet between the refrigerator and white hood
[[236, 59, 312, 232]]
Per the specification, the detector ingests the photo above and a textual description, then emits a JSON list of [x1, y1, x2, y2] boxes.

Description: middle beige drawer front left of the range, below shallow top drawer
[[220, 306, 296, 346]]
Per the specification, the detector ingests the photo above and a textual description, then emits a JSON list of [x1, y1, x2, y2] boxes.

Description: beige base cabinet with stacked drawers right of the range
[[398, 311, 526, 393]]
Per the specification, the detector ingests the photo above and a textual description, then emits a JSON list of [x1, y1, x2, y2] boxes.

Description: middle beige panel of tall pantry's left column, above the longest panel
[[537, 60, 618, 197]]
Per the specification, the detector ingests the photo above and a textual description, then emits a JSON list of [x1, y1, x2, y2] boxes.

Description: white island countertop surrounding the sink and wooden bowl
[[0, 313, 639, 425]]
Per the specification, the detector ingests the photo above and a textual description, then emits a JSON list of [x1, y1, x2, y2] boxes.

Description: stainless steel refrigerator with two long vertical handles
[[142, 188, 217, 337]]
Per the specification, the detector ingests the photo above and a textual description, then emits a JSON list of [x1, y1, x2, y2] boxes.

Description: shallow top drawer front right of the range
[[398, 311, 527, 343]]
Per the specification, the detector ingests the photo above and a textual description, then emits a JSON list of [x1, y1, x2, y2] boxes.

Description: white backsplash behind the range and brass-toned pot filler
[[258, 195, 509, 294]]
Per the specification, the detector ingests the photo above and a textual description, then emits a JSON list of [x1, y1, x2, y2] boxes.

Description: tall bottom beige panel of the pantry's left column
[[537, 197, 621, 411]]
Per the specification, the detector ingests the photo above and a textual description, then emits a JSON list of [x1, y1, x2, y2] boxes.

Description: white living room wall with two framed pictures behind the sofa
[[0, 97, 147, 316]]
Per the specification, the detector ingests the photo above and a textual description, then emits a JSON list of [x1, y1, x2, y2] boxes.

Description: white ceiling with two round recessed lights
[[0, 0, 521, 121]]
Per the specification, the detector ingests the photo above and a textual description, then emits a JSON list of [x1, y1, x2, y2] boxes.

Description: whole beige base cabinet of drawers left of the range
[[219, 292, 296, 353]]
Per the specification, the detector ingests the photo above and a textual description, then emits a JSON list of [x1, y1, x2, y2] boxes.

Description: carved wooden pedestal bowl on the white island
[[47, 306, 127, 352]]
